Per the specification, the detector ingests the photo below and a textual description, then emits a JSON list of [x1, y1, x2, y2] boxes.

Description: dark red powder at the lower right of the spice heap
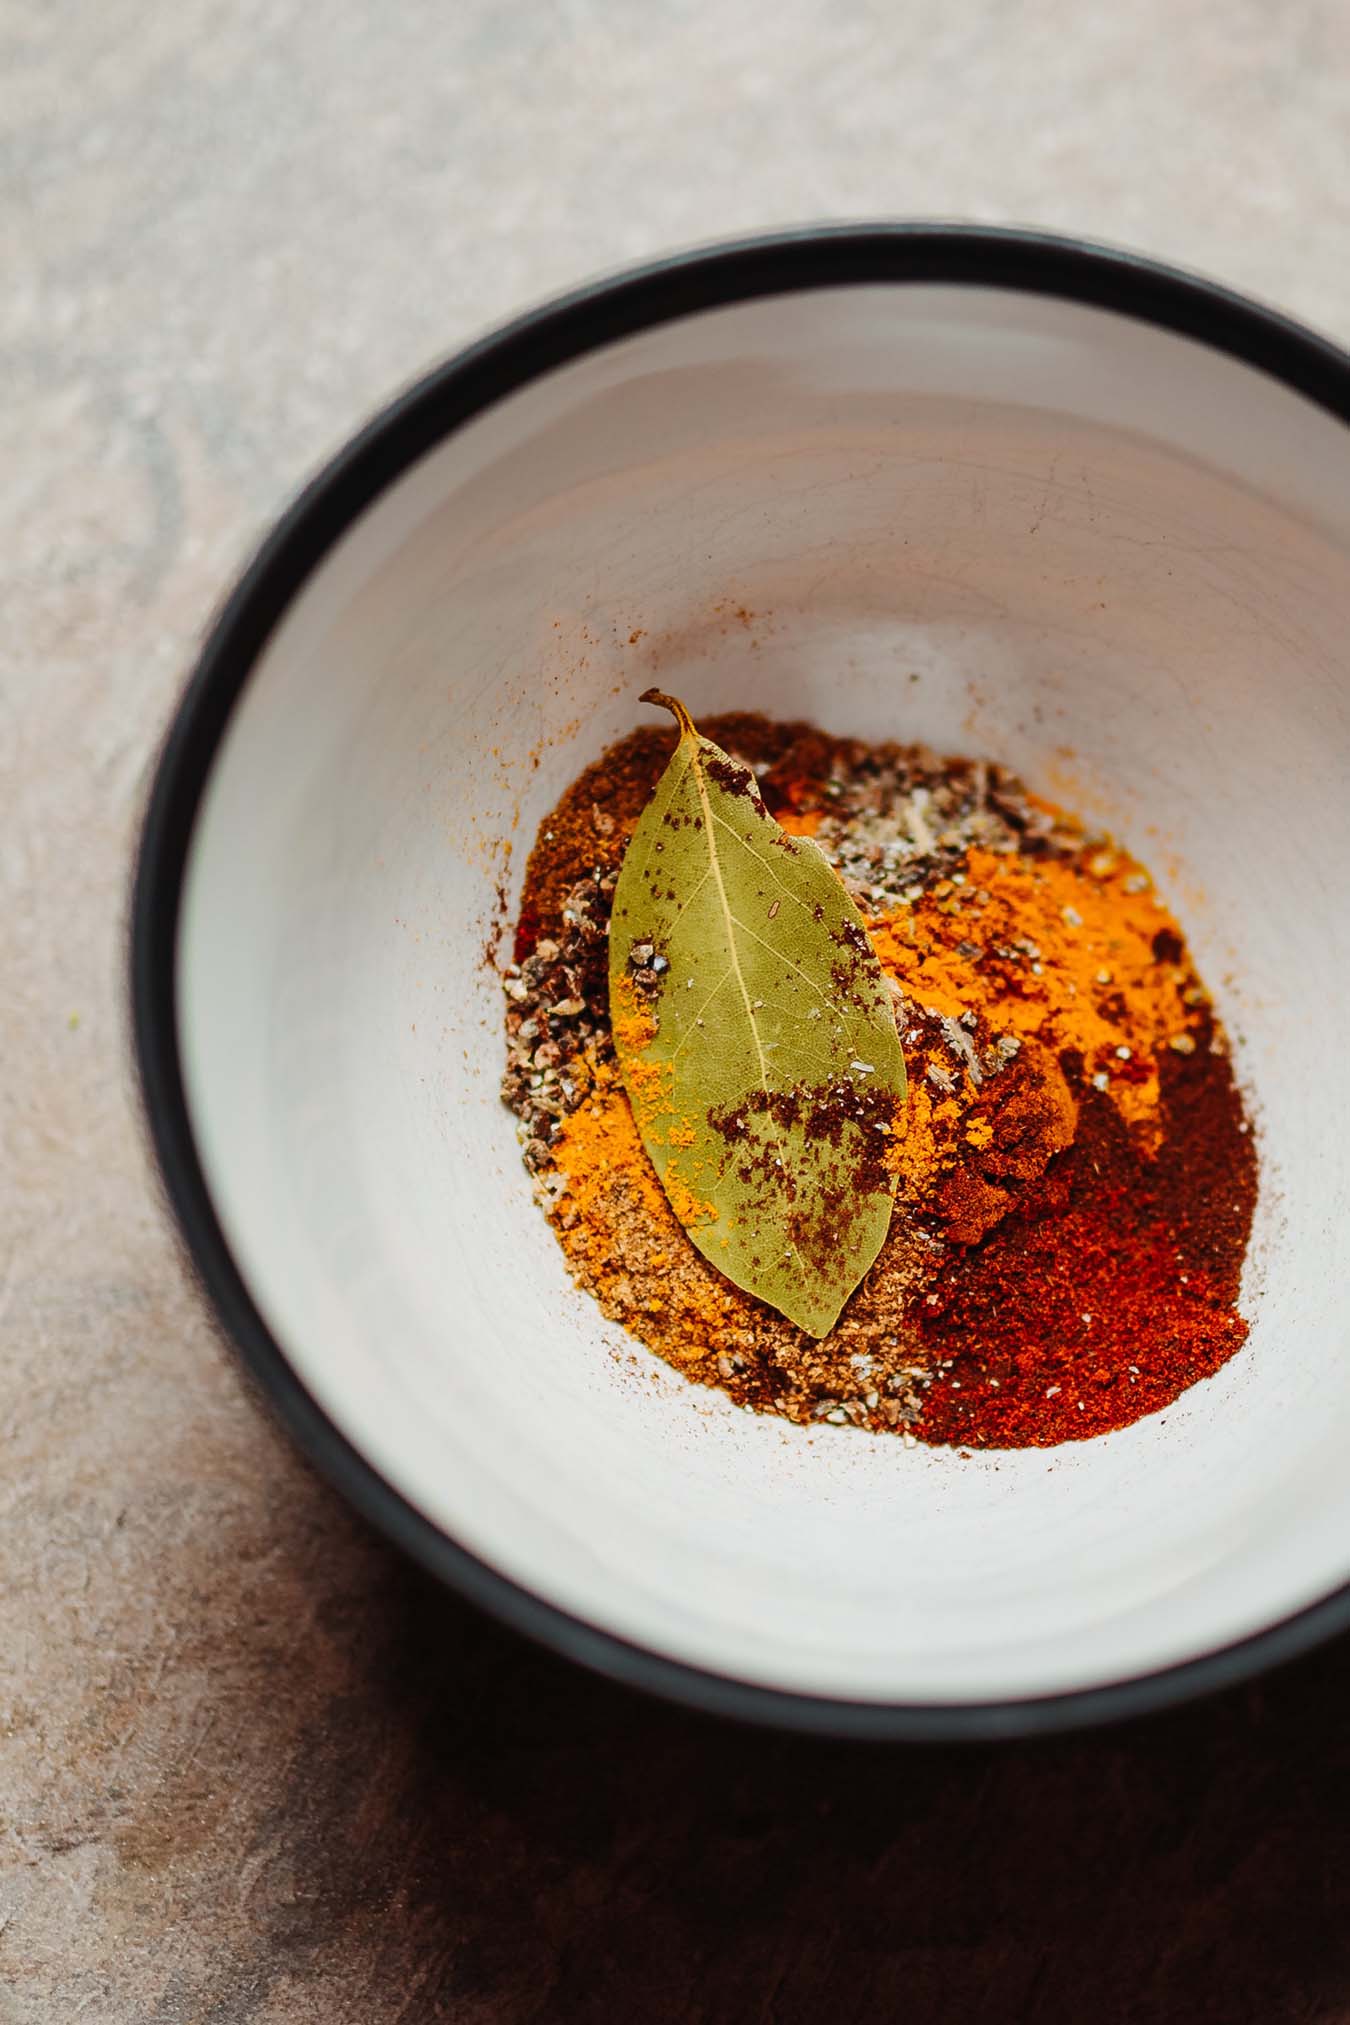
[[915, 1028, 1257, 1448]]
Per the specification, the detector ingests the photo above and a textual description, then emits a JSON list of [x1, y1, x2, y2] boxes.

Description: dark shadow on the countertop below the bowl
[[162, 1506, 1350, 2025]]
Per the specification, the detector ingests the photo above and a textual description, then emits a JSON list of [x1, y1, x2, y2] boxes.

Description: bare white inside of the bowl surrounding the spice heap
[[178, 286, 1350, 1703]]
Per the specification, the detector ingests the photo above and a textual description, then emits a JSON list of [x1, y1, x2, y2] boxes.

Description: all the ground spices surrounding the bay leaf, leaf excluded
[[502, 715, 1257, 1448]]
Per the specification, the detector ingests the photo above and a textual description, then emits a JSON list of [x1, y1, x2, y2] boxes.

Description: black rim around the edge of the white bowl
[[130, 223, 1350, 1742]]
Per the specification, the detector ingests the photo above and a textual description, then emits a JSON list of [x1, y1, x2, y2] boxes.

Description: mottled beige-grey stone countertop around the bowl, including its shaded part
[[0, 0, 1350, 2025]]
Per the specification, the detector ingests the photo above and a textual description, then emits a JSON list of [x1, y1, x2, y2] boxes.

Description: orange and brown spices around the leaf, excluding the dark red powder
[[504, 717, 1247, 1442]]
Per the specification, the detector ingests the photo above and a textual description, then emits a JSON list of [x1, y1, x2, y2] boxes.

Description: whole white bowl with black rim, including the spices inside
[[134, 229, 1350, 1735]]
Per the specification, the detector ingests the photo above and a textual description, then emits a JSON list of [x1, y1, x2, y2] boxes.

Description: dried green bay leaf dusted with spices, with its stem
[[609, 689, 905, 1337]]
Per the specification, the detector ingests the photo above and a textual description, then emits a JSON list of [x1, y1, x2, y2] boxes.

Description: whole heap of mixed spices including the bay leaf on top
[[502, 693, 1257, 1450]]
